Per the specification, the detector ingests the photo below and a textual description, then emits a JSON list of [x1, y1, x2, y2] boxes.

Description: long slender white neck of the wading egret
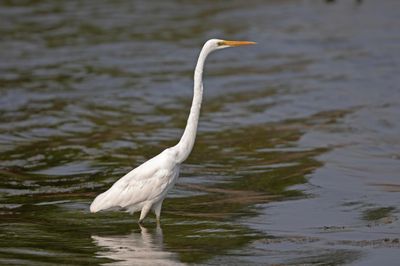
[[174, 45, 212, 163]]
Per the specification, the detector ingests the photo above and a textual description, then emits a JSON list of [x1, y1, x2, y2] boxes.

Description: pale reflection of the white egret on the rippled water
[[92, 226, 182, 265]]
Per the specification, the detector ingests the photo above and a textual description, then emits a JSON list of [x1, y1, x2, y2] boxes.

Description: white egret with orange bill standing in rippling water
[[90, 39, 255, 224]]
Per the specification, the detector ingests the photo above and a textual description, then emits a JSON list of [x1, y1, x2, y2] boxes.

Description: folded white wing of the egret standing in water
[[90, 157, 170, 212]]
